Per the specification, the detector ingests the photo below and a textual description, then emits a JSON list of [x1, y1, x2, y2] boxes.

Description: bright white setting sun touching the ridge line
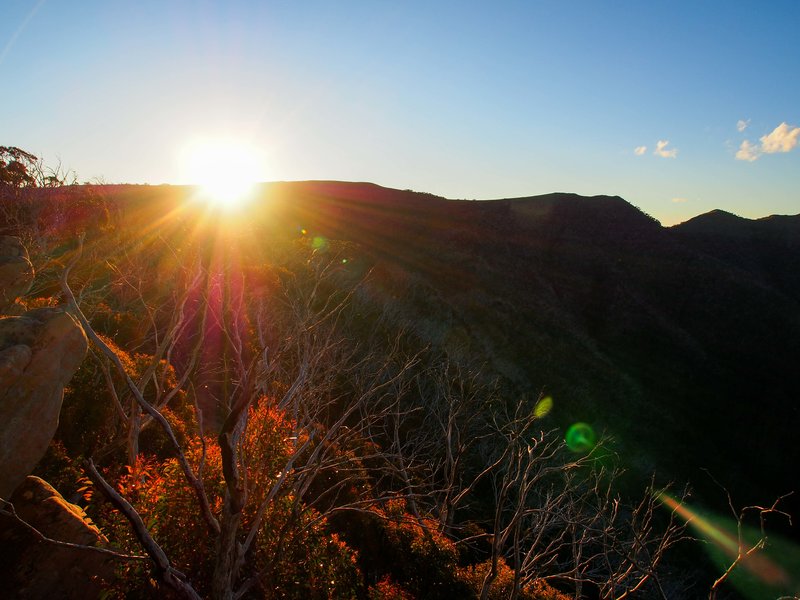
[[181, 139, 264, 211]]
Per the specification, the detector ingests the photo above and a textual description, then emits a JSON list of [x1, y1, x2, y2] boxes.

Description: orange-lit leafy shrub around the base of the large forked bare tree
[[95, 399, 361, 598]]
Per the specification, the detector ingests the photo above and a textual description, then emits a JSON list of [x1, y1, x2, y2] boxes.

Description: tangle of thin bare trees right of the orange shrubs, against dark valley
[[410, 370, 684, 598]]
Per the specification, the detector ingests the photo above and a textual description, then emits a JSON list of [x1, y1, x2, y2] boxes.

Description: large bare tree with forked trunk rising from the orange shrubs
[[61, 237, 424, 599]]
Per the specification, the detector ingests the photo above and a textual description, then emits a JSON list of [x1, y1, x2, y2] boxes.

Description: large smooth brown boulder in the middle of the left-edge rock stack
[[0, 308, 87, 498]]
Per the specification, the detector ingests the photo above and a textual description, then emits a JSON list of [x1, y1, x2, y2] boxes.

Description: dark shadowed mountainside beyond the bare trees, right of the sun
[[247, 182, 800, 501]]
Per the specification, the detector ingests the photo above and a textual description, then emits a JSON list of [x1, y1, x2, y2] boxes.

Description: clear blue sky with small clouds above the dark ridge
[[0, 0, 800, 225]]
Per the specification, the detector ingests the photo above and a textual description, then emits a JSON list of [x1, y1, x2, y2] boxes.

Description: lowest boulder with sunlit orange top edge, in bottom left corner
[[0, 476, 115, 599]]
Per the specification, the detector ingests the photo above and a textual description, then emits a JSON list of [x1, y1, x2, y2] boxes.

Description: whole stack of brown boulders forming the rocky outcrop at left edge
[[0, 236, 108, 598]]
